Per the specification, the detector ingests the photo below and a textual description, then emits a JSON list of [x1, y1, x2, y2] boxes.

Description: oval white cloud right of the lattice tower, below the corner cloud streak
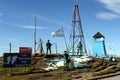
[[96, 12, 120, 20]]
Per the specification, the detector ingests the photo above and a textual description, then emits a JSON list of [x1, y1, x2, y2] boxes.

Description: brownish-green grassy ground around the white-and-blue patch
[[0, 55, 120, 80]]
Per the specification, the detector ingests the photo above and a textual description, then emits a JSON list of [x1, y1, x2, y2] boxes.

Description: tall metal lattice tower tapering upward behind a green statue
[[69, 5, 87, 55]]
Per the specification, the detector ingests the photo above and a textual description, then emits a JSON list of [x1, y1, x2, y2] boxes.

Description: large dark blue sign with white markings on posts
[[3, 53, 31, 68]]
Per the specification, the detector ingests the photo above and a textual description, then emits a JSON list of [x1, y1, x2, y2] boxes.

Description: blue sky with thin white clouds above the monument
[[0, 0, 120, 56]]
